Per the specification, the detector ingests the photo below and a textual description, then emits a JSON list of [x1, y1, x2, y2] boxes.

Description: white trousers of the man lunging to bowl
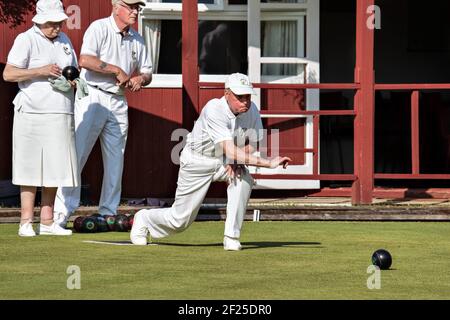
[[140, 148, 253, 239]]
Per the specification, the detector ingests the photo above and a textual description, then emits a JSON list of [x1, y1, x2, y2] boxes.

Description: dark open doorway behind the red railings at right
[[320, 0, 450, 187]]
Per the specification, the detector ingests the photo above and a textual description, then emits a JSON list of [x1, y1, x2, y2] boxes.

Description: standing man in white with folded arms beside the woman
[[55, 0, 152, 226]]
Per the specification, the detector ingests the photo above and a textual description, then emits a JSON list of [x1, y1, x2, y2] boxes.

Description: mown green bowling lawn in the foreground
[[0, 221, 450, 300]]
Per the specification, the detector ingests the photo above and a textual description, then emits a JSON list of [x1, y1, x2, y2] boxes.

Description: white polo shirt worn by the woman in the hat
[[7, 25, 78, 114]]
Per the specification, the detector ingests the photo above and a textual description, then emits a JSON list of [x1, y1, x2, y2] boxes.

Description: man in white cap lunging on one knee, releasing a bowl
[[130, 73, 291, 251]]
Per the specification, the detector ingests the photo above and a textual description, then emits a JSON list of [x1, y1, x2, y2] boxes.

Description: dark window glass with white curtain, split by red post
[[144, 20, 248, 74]]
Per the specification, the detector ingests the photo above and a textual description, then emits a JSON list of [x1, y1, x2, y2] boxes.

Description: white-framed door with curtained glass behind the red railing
[[248, 0, 320, 189]]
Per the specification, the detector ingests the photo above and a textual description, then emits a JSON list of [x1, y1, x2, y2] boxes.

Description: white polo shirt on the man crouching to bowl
[[185, 97, 263, 157]]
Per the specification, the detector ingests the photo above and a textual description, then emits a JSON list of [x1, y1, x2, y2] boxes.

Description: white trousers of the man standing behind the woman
[[54, 86, 128, 215]]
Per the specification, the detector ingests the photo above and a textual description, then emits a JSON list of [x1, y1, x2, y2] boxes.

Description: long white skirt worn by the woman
[[12, 111, 79, 187]]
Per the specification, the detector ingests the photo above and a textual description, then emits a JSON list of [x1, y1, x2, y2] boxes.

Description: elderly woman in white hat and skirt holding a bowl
[[3, 0, 79, 237]]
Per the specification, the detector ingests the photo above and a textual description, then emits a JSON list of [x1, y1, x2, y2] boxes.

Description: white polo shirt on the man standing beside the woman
[[80, 16, 152, 94]]
